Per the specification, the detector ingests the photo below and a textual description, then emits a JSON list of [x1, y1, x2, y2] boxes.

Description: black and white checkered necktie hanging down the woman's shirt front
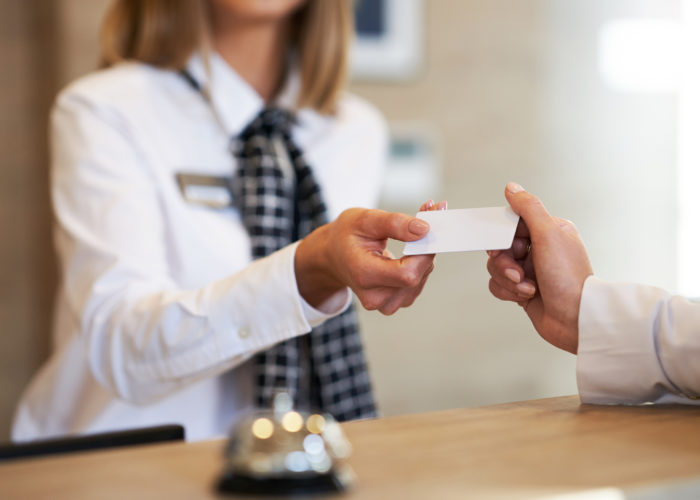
[[231, 108, 375, 421]]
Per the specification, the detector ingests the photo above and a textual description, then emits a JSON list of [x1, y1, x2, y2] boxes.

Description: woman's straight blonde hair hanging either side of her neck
[[100, 0, 353, 114]]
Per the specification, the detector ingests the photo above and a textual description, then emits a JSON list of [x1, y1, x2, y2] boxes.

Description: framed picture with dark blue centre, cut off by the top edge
[[351, 0, 424, 81]]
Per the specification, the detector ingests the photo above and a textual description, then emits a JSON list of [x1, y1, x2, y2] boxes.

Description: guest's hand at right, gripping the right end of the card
[[487, 183, 593, 354]]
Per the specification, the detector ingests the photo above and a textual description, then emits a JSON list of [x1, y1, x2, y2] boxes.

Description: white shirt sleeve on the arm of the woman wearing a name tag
[[52, 94, 340, 404]]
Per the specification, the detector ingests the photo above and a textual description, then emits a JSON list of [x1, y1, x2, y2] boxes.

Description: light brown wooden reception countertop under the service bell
[[0, 396, 700, 500]]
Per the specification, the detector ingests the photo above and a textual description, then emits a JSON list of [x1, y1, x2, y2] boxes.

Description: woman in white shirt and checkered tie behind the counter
[[13, 0, 432, 440]]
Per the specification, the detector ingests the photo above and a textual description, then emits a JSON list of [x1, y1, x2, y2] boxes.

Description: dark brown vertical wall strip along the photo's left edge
[[0, 0, 55, 440]]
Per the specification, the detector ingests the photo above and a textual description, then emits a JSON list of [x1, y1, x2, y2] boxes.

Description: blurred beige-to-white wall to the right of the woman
[[353, 0, 678, 414]]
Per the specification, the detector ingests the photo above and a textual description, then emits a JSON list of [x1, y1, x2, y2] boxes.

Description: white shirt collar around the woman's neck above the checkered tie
[[187, 52, 301, 135]]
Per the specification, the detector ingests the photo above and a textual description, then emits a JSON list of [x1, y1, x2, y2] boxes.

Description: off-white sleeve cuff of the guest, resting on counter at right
[[577, 277, 700, 404]]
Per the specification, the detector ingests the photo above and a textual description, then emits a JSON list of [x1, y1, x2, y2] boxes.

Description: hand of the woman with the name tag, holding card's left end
[[294, 203, 439, 314]]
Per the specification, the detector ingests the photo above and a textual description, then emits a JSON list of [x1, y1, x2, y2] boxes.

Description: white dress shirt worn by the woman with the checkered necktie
[[12, 55, 387, 440]]
